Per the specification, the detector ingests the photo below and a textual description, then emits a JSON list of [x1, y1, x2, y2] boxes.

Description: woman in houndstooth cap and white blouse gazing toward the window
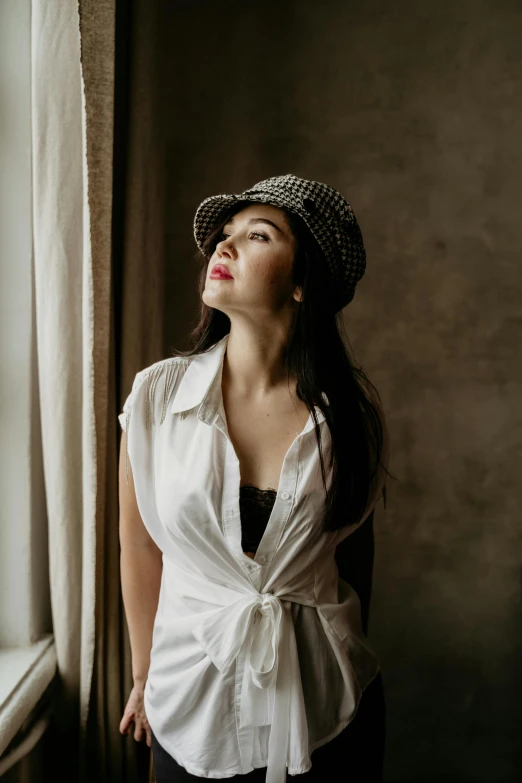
[[119, 174, 389, 783]]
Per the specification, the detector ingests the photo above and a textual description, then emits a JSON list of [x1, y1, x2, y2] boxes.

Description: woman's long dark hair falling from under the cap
[[171, 201, 388, 531]]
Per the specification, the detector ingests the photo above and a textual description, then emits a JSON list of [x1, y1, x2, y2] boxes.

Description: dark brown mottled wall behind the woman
[[165, 0, 522, 783]]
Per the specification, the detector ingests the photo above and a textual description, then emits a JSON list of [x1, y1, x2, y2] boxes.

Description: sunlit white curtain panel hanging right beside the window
[[31, 0, 106, 767]]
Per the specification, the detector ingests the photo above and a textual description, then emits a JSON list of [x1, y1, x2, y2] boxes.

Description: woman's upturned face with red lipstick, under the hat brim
[[203, 204, 301, 316]]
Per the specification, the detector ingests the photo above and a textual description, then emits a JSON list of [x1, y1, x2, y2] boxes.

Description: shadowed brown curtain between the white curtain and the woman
[[79, 0, 165, 783]]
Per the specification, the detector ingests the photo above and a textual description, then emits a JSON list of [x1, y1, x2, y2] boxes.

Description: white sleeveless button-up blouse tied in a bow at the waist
[[118, 335, 387, 783]]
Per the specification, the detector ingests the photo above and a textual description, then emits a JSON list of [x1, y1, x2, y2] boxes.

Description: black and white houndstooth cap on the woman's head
[[194, 174, 366, 312]]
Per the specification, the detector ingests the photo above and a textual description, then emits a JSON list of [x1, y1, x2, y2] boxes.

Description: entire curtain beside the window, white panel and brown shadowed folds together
[[32, 0, 164, 783]]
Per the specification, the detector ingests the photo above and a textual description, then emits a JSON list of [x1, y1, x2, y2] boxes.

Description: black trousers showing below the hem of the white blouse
[[152, 672, 386, 783]]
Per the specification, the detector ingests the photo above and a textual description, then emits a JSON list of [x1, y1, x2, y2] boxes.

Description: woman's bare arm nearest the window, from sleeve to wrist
[[118, 432, 163, 686]]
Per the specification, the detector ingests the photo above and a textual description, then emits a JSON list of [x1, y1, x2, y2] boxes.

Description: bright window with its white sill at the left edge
[[0, 0, 56, 774]]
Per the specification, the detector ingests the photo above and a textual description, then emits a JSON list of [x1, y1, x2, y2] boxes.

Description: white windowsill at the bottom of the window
[[0, 634, 58, 756]]
